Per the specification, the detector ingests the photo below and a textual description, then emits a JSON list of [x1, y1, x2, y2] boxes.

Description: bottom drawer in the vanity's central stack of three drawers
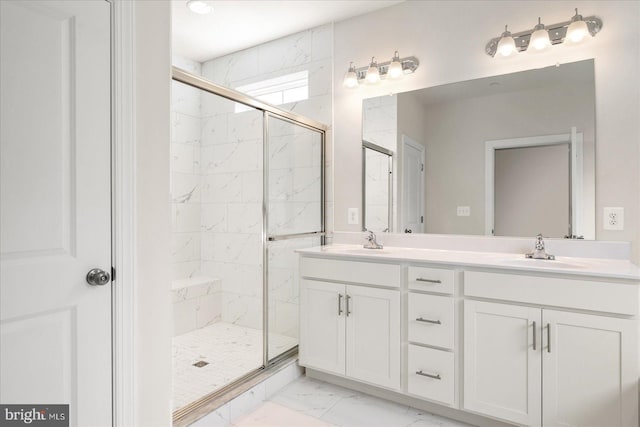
[[407, 344, 455, 405]]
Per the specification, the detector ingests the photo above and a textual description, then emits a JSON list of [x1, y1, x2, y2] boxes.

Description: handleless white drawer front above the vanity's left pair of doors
[[300, 257, 400, 288]]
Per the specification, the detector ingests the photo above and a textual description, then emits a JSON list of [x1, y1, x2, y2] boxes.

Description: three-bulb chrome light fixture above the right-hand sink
[[485, 9, 602, 57]]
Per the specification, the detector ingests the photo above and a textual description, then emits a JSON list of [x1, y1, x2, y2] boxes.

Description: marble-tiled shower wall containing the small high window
[[201, 26, 332, 337]]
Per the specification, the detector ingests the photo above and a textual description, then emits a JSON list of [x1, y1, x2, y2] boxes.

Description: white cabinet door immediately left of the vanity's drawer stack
[[345, 286, 400, 389]]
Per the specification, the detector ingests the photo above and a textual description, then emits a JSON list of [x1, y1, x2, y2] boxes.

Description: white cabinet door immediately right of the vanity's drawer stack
[[464, 300, 542, 426]]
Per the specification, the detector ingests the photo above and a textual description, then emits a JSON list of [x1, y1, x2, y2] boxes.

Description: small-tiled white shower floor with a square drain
[[173, 322, 298, 410]]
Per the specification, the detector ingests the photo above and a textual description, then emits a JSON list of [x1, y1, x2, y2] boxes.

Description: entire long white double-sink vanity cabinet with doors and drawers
[[299, 246, 640, 427]]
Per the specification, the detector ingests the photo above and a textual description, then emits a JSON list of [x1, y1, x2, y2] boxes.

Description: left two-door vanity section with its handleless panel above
[[299, 258, 401, 389]]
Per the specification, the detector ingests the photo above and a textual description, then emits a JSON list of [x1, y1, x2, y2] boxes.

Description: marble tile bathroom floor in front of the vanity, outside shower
[[200, 377, 470, 427]]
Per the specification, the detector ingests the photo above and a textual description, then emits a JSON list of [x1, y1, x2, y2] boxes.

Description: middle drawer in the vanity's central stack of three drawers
[[407, 293, 455, 349]]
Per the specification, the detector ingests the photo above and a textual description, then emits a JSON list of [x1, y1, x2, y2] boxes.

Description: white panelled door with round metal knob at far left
[[0, 0, 111, 426]]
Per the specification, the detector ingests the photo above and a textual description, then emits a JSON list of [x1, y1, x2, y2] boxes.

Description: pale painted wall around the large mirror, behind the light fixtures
[[334, 1, 640, 260]]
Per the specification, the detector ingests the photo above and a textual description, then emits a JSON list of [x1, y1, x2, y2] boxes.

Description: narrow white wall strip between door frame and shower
[[133, 1, 171, 427]]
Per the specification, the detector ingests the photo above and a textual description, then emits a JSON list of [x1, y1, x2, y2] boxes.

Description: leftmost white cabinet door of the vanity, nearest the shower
[[299, 280, 346, 375]]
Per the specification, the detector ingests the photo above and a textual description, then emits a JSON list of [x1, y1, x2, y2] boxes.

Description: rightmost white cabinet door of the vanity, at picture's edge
[[542, 310, 638, 427]]
